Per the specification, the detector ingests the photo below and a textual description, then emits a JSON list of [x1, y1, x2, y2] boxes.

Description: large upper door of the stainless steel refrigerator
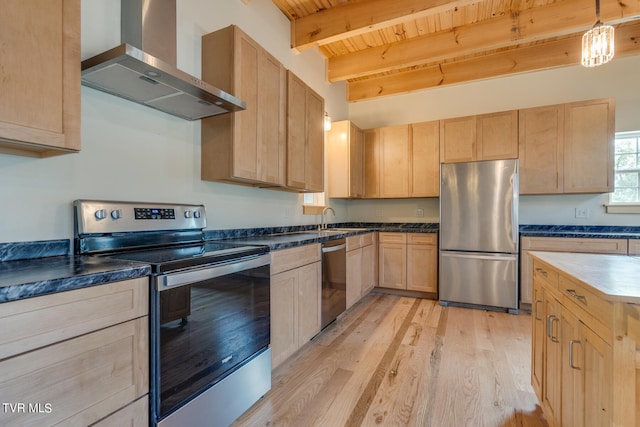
[[440, 160, 518, 253]]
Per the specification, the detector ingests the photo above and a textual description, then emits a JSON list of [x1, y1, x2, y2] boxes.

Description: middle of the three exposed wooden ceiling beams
[[327, 0, 640, 82]]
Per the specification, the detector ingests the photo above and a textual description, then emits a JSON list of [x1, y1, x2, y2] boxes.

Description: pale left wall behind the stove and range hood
[[0, 0, 347, 242]]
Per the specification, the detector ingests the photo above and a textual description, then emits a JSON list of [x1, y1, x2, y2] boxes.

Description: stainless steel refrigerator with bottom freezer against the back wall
[[438, 160, 518, 312]]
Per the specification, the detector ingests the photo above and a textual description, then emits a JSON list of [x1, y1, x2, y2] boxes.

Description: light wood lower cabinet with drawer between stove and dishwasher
[[271, 244, 322, 369]]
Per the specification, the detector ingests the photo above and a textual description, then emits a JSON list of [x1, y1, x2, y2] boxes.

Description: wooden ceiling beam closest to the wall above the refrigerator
[[347, 22, 640, 102]]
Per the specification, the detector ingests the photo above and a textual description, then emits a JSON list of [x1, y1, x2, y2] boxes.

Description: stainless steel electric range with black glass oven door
[[74, 200, 271, 427]]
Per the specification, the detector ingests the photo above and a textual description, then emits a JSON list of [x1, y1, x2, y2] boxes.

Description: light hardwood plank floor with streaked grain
[[234, 293, 547, 427]]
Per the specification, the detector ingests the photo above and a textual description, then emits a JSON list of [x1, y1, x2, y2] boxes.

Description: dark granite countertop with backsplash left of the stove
[[0, 240, 151, 303]]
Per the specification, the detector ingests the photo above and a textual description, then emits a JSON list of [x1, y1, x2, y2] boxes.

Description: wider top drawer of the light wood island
[[560, 276, 613, 331]]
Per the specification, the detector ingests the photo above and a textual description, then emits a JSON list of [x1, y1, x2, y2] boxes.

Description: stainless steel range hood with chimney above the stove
[[82, 0, 246, 120]]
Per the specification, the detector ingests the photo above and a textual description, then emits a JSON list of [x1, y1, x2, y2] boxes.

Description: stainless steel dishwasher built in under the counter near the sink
[[321, 239, 347, 329]]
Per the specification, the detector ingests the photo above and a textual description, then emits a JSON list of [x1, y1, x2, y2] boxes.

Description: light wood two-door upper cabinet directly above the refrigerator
[[440, 110, 518, 163]]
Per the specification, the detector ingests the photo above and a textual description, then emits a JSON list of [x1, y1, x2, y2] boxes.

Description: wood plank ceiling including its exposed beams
[[272, 0, 640, 102]]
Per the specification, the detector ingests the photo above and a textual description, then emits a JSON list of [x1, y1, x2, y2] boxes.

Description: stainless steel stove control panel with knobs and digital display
[[73, 200, 207, 235]]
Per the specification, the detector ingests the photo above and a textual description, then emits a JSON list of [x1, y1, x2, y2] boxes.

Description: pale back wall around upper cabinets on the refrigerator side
[[348, 56, 640, 226]]
